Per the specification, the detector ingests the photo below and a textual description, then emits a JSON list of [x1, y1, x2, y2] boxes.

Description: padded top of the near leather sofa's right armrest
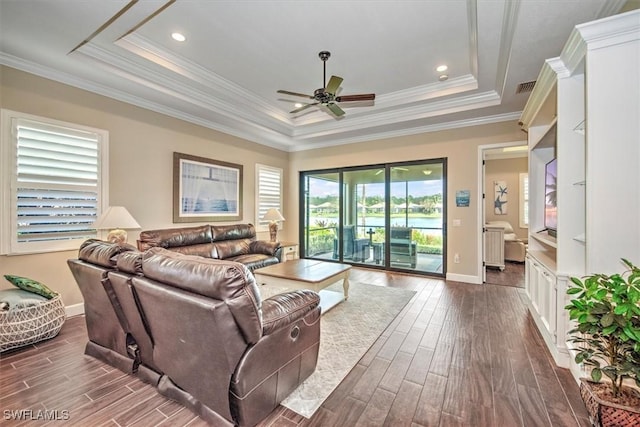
[[262, 290, 320, 335]]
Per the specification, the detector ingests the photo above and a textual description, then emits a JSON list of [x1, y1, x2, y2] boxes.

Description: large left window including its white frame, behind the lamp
[[0, 110, 108, 254]]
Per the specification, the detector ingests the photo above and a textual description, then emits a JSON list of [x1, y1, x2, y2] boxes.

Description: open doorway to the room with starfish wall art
[[480, 142, 529, 288]]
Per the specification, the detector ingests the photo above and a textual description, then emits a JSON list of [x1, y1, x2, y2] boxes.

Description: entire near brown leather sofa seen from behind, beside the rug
[[68, 240, 320, 426]]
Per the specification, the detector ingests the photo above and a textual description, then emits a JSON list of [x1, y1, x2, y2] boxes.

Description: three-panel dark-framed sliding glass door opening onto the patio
[[300, 159, 446, 274]]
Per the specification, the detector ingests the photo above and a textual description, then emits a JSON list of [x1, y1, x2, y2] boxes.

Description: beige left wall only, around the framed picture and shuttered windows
[[0, 67, 288, 306]]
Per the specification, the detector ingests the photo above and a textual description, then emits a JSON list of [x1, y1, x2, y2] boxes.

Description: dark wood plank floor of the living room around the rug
[[0, 268, 589, 427]]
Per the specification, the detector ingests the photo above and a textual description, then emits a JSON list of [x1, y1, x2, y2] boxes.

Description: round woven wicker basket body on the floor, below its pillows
[[0, 295, 66, 351]]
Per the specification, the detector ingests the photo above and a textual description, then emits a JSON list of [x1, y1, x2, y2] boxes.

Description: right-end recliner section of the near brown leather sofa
[[131, 248, 320, 426]]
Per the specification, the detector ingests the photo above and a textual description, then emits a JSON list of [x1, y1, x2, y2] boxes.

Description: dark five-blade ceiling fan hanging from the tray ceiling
[[278, 50, 376, 117]]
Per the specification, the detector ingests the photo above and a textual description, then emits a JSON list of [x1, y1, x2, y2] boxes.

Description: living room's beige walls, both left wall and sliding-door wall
[[0, 67, 522, 306]]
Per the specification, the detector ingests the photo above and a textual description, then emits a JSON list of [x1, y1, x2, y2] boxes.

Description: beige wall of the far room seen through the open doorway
[[484, 157, 529, 239]]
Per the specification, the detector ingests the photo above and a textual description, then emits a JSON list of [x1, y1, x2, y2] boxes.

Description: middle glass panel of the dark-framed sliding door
[[342, 166, 386, 266]]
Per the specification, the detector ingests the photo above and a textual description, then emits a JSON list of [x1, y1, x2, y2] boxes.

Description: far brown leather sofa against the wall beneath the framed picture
[[138, 224, 282, 271]]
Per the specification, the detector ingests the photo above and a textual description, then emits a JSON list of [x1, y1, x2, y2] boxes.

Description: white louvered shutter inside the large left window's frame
[[12, 119, 100, 244]]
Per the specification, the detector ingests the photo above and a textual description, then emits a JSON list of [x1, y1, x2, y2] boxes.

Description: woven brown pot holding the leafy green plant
[[580, 378, 640, 427]]
